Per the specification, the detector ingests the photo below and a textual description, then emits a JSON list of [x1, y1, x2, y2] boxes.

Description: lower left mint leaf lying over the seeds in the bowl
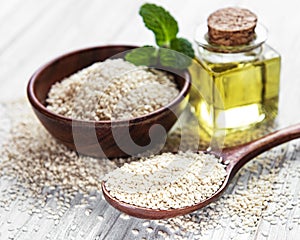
[[125, 46, 157, 66]]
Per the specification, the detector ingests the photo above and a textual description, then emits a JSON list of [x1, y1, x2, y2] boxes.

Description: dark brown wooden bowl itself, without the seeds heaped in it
[[27, 46, 191, 158]]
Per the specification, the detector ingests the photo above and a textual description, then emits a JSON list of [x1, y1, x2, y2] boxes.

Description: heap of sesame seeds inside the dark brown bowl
[[46, 59, 179, 121]]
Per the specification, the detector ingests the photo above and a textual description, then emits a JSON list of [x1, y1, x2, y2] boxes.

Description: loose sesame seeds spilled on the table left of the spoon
[[0, 104, 121, 217]]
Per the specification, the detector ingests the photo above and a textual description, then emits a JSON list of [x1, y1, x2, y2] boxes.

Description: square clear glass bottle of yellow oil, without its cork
[[191, 24, 281, 134]]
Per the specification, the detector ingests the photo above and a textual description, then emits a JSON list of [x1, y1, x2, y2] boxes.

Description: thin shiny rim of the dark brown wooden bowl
[[27, 44, 191, 126]]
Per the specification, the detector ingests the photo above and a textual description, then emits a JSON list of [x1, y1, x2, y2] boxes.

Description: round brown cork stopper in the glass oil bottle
[[207, 7, 257, 46]]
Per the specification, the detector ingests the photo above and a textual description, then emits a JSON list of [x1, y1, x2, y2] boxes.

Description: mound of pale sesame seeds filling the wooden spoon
[[104, 151, 226, 209]]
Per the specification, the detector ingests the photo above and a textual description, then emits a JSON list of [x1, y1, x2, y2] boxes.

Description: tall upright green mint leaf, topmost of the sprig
[[139, 3, 178, 47]]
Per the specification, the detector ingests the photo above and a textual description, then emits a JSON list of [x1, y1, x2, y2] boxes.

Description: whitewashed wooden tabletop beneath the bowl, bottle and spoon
[[0, 0, 300, 240]]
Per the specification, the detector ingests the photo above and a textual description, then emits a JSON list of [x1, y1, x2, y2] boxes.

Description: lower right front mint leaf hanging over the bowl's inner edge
[[159, 48, 192, 69]]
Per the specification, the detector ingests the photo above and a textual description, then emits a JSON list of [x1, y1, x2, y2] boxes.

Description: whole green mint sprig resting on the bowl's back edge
[[125, 3, 195, 69]]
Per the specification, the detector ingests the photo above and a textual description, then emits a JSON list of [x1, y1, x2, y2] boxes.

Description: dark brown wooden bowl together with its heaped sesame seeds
[[27, 45, 191, 158]]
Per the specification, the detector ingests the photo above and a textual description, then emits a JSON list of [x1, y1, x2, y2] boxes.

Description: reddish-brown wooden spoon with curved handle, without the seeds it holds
[[102, 124, 300, 219]]
